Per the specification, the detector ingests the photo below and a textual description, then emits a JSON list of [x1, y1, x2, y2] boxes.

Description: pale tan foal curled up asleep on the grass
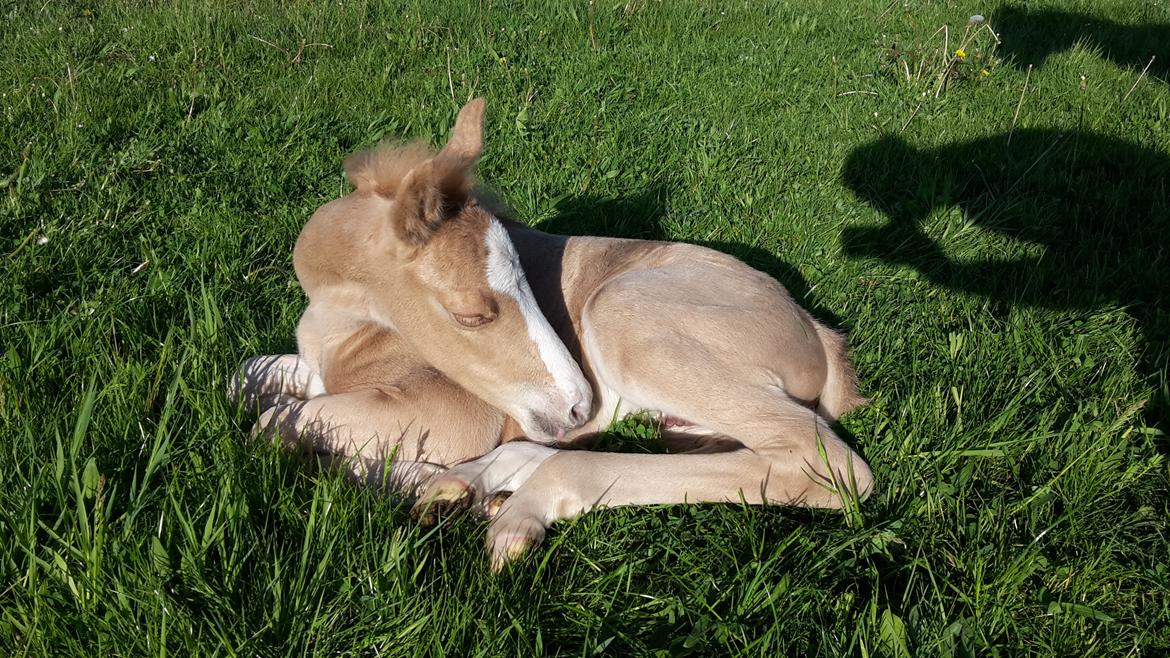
[[232, 100, 873, 568]]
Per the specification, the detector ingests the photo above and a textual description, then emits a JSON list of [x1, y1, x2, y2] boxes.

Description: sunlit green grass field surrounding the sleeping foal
[[0, 0, 1170, 657]]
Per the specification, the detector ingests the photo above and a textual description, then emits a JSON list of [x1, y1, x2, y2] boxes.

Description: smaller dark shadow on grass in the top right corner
[[991, 6, 1170, 82]]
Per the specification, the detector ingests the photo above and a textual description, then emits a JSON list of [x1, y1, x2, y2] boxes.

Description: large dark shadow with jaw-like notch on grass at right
[[841, 130, 1170, 426]]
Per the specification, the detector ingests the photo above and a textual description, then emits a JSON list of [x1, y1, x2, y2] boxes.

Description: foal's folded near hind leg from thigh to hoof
[[479, 272, 873, 567]]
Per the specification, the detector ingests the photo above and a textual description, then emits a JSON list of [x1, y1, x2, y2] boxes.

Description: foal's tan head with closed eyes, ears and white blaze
[[294, 98, 592, 441]]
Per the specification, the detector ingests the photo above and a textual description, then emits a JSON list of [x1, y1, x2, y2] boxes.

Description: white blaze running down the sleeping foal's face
[[486, 219, 591, 414]]
